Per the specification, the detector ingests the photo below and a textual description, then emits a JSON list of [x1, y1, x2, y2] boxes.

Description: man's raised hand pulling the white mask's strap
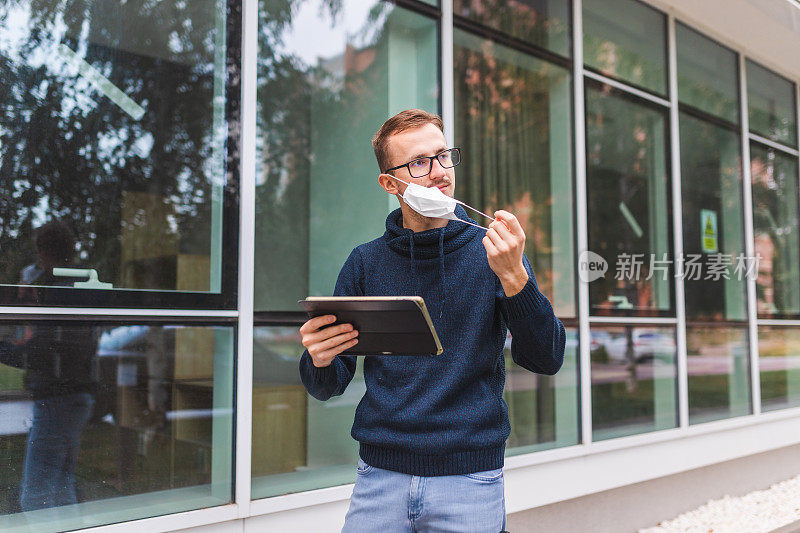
[[483, 211, 528, 296]]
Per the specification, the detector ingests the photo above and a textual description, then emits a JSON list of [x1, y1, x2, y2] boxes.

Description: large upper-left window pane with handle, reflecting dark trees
[[0, 0, 235, 304]]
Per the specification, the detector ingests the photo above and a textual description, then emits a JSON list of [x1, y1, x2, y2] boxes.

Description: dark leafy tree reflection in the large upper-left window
[[0, 0, 221, 289]]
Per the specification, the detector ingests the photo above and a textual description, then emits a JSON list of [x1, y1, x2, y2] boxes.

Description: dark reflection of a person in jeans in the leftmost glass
[[0, 222, 97, 511]]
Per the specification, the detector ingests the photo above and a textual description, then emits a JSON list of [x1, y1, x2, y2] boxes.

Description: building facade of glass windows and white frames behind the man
[[0, 0, 800, 532]]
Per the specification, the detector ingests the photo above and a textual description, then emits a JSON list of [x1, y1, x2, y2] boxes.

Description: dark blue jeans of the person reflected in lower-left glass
[[20, 393, 94, 511]]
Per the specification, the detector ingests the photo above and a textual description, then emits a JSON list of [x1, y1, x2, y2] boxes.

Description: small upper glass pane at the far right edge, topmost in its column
[[747, 60, 797, 148]]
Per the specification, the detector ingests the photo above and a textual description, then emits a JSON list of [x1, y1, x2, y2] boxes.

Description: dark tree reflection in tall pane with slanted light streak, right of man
[[586, 86, 666, 310]]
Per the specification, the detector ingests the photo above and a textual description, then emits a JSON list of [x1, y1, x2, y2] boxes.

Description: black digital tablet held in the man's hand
[[297, 296, 442, 355]]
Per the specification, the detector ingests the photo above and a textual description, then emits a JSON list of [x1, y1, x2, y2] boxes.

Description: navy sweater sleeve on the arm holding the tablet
[[300, 249, 363, 401]]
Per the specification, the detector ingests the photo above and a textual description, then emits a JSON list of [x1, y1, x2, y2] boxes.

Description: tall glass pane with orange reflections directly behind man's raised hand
[[454, 30, 576, 316]]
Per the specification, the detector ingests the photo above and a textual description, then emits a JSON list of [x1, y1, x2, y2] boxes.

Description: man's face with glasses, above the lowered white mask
[[388, 124, 456, 198]]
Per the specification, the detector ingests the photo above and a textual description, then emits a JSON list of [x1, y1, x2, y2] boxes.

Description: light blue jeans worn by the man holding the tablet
[[342, 459, 506, 533]]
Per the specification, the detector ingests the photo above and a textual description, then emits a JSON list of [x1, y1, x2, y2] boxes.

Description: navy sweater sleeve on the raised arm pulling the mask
[[499, 256, 566, 375]]
